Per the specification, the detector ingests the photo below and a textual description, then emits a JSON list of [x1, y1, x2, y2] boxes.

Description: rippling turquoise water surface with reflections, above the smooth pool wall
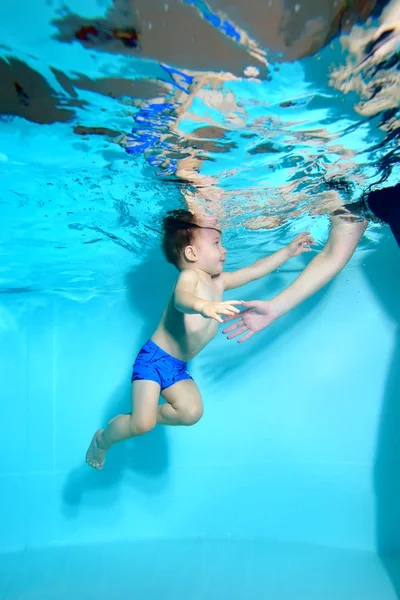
[[0, 0, 398, 291]]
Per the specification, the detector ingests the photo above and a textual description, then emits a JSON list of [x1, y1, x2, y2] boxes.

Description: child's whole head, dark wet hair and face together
[[163, 209, 226, 275]]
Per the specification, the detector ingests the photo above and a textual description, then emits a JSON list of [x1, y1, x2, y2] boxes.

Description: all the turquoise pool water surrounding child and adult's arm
[[0, 0, 400, 600]]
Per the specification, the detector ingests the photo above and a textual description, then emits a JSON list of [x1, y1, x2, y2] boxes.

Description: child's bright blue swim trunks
[[131, 340, 193, 390]]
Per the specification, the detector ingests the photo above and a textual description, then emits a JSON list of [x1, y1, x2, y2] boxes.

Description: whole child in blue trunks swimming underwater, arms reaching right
[[86, 210, 313, 469]]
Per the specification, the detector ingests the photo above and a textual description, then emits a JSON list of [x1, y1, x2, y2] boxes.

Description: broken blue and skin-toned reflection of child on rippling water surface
[[119, 64, 248, 215]]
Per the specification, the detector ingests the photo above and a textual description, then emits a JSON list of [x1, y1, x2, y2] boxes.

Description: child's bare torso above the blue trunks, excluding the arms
[[151, 275, 224, 362]]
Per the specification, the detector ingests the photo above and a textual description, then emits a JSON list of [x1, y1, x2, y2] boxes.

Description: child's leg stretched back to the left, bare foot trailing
[[86, 380, 160, 469]]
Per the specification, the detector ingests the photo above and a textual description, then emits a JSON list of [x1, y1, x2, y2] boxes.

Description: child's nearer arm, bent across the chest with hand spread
[[174, 269, 242, 323]]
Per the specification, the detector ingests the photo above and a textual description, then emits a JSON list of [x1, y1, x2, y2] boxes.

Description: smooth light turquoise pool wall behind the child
[[0, 233, 400, 552]]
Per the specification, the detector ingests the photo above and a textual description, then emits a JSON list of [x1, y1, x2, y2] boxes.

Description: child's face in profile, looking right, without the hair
[[192, 228, 226, 275]]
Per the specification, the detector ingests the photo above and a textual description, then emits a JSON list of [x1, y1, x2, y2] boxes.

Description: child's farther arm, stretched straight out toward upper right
[[223, 232, 314, 290]]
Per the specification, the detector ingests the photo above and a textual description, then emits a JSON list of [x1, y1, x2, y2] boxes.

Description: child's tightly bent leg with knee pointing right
[[157, 379, 203, 425]]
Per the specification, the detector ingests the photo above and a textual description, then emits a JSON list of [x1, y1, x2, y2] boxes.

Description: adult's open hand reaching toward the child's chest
[[222, 300, 279, 344]]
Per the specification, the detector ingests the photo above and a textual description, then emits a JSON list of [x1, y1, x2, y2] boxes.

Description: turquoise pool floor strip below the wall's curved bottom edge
[[0, 539, 400, 600]]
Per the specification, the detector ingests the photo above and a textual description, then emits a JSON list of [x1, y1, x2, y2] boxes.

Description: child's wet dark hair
[[162, 208, 201, 269]]
